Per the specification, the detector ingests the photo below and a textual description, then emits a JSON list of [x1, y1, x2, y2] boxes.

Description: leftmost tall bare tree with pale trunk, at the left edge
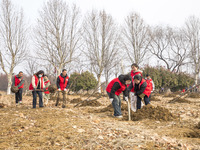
[[0, 0, 28, 94]]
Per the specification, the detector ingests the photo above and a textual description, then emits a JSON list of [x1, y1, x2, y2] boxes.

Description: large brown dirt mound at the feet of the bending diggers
[[132, 105, 176, 121]]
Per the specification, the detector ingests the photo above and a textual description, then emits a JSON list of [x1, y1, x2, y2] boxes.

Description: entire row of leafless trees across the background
[[0, 0, 200, 94]]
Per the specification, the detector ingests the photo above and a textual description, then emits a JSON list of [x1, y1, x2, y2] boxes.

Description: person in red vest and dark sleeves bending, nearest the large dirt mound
[[128, 75, 151, 109]]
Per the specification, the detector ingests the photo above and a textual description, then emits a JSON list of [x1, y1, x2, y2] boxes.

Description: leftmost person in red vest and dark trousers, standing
[[12, 71, 24, 105]]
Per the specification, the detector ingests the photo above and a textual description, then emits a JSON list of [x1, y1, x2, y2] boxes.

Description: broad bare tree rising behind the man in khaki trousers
[[35, 0, 80, 74]]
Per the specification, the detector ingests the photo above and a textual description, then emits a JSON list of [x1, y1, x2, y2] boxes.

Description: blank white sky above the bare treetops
[[12, 0, 200, 27]]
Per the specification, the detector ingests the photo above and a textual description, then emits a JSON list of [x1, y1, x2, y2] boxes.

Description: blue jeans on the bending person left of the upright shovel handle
[[107, 92, 122, 116]]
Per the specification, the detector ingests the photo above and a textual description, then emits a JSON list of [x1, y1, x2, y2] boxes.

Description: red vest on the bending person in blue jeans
[[106, 78, 126, 96]]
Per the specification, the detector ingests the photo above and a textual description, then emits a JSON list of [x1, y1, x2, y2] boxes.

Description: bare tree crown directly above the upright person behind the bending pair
[[122, 13, 149, 64]]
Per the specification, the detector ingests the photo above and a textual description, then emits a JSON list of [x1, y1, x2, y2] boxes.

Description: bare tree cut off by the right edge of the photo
[[184, 16, 200, 84]]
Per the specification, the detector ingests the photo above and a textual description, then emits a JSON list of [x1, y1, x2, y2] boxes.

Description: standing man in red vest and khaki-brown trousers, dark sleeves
[[56, 69, 69, 108]]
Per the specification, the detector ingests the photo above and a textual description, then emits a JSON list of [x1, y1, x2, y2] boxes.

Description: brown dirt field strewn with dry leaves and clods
[[0, 92, 200, 150]]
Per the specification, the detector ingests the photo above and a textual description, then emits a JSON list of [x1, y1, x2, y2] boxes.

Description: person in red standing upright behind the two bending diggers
[[130, 63, 142, 103]]
